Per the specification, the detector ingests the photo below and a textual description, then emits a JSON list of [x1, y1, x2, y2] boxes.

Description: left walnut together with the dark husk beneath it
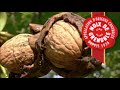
[[0, 34, 50, 78]]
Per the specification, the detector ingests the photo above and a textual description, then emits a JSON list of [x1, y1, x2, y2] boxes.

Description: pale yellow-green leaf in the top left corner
[[0, 12, 7, 31]]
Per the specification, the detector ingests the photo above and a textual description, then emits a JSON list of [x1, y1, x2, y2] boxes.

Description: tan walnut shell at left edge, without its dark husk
[[0, 34, 34, 73]]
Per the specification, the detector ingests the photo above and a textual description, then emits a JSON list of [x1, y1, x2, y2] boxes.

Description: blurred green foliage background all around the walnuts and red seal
[[0, 12, 120, 78]]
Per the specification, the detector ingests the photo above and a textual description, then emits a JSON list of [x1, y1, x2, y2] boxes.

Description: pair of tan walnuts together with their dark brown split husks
[[0, 12, 101, 78]]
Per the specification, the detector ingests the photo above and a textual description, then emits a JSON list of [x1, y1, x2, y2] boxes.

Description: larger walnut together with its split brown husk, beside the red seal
[[36, 12, 101, 77]]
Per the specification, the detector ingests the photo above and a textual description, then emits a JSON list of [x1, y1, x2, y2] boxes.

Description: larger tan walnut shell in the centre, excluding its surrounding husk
[[44, 20, 83, 70]]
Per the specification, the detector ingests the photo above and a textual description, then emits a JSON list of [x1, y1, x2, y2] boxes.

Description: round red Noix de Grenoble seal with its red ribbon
[[82, 12, 118, 63]]
